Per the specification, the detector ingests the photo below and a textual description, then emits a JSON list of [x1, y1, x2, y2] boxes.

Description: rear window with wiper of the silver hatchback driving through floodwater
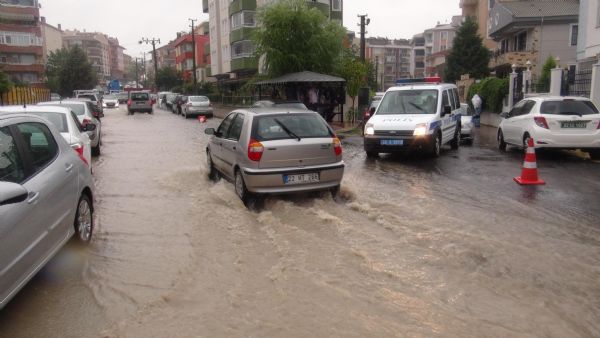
[[252, 113, 333, 141]]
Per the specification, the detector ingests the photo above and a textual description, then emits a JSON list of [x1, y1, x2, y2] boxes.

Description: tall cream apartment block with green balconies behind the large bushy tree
[[203, 0, 343, 88]]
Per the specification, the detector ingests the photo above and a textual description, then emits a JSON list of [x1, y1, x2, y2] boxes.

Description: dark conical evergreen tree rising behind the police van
[[444, 17, 491, 82]]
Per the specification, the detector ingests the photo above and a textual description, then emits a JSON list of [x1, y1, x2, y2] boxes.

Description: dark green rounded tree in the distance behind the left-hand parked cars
[[46, 46, 98, 96]]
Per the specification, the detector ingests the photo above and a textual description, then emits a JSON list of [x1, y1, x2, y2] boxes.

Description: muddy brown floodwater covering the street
[[0, 107, 600, 337]]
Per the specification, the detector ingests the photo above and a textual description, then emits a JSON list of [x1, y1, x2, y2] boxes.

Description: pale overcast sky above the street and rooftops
[[40, 0, 461, 56]]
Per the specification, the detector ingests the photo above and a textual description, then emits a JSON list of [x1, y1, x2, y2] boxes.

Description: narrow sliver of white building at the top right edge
[[577, 0, 600, 70]]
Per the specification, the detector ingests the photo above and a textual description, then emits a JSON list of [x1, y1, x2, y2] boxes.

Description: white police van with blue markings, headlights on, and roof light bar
[[364, 77, 462, 157]]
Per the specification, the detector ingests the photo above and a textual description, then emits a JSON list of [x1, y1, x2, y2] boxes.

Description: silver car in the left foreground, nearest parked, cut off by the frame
[[0, 111, 94, 309]]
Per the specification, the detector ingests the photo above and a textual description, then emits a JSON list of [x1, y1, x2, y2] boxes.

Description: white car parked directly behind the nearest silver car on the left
[[0, 106, 96, 172]]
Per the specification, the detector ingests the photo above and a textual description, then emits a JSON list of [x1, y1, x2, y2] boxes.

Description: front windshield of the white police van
[[376, 89, 438, 115]]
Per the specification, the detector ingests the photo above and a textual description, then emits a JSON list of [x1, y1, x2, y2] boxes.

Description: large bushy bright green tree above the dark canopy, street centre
[[253, 0, 345, 76]]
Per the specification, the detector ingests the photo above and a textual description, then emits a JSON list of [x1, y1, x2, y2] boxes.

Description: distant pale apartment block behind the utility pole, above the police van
[[365, 38, 412, 91]]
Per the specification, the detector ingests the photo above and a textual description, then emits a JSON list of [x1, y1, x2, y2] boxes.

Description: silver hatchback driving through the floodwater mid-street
[[205, 108, 344, 204]]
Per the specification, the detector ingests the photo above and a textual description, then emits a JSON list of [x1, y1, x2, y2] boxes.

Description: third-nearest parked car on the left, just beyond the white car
[[38, 99, 103, 156]]
